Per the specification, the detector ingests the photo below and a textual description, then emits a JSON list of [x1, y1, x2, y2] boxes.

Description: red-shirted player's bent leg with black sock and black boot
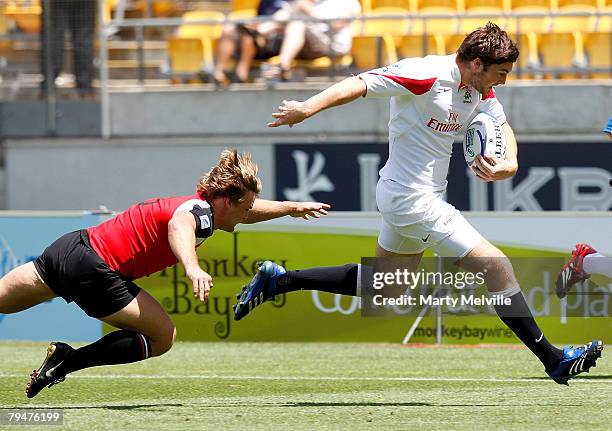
[[26, 290, 176, 398]]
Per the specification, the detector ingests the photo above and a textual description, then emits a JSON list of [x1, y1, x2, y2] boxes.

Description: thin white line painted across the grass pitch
[[0, 374, 612, 384]]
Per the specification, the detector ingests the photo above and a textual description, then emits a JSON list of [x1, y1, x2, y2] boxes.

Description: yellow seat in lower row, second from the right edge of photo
[[538, 31, 586, 78]]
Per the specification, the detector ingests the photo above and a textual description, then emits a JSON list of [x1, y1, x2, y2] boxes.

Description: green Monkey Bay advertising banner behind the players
[[138, 213, 612, 344]]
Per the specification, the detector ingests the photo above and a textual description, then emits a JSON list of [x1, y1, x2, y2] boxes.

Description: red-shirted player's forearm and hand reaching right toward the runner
[[243, 199, 330, 224]]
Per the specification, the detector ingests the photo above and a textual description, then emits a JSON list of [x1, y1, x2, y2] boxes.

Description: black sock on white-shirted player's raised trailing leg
[[276, 264, 359, 296]]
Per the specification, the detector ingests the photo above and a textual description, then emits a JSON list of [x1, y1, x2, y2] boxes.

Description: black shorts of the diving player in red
[[34, 230, 140, 318]]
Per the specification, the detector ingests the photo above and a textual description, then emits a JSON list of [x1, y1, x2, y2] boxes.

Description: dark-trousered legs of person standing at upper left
[[40, 0, 97, 98]]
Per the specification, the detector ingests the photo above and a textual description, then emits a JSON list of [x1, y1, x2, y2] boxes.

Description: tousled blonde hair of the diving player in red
[[197, 149, 261, 203]]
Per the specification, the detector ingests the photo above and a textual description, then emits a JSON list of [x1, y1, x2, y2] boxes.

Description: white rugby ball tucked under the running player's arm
[[463, 113, 506, 166]]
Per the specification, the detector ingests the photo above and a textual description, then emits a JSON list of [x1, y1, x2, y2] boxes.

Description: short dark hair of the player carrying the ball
[[457, 22, 519, 68]]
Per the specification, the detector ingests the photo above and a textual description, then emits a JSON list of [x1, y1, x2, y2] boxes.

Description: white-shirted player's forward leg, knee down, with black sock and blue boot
[[459, 238, 603, 384]]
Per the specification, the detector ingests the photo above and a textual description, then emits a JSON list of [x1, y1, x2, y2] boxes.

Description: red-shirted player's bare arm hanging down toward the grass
[[168, 211, 213, 302]]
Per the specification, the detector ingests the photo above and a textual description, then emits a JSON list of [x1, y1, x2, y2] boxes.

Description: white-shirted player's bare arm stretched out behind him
[[268, 76, 367, 127]]
